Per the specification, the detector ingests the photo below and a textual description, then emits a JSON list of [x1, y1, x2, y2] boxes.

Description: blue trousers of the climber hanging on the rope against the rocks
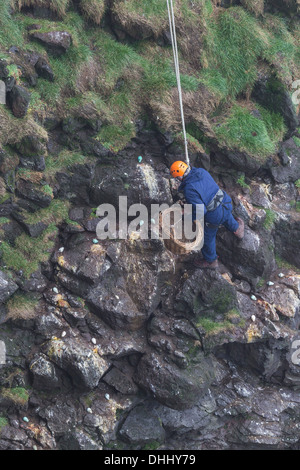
[[201, 193, 239, 261]]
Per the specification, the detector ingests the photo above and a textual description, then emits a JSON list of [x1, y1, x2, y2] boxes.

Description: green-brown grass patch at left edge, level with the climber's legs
[[0, 224, 58, 279]]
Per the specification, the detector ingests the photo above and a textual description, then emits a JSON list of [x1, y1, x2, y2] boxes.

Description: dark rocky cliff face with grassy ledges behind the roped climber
[[0, 0, 300, 450]]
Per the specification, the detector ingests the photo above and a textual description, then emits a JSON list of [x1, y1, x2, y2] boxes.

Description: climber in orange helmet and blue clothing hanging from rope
[[170, 161, 244, 269]]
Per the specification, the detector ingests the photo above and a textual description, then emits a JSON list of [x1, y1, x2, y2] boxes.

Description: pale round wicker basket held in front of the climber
[[159, 207, 204, 255]]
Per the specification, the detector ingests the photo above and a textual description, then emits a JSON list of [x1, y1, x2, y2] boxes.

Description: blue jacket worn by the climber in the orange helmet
[[178, 167, 232, 224]]
